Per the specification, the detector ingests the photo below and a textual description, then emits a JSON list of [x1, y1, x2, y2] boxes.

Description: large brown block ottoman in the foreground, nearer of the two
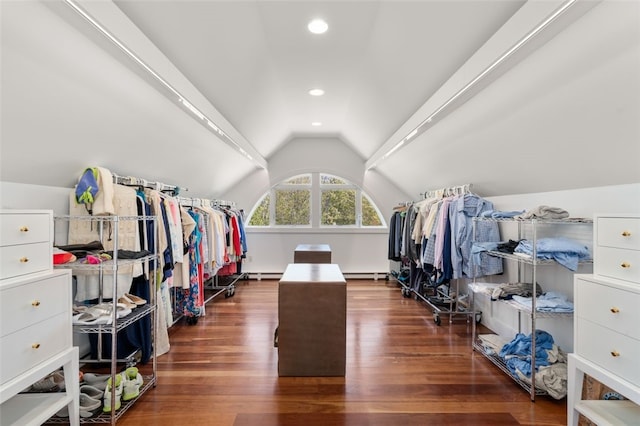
[[278, 263, 347, 376]]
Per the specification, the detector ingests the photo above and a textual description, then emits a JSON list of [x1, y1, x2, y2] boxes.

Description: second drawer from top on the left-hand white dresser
[[0, 242, 53, 279]]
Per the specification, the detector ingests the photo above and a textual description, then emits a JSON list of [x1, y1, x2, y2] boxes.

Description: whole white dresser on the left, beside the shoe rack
[[0, 210, 79, 426]]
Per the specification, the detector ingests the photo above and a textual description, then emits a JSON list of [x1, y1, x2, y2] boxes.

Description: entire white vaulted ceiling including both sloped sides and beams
[[0, 0, 640, 198]]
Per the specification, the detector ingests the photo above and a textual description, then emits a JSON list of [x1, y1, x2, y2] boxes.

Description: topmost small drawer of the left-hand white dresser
[[0, 212, 53, 246]]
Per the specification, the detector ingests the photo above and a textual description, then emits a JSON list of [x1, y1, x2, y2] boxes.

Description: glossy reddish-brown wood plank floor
[[118, 280, 567, 426]]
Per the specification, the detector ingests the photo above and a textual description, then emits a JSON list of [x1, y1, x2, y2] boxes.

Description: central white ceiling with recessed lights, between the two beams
[[115, 0, 524, 159]]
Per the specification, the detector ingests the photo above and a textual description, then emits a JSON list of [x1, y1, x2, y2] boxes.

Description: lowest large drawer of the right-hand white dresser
[[574, 318, 640, 386]]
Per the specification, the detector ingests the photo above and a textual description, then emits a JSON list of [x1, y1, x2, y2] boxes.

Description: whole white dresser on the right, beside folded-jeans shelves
[[567, 215, 640, 425]]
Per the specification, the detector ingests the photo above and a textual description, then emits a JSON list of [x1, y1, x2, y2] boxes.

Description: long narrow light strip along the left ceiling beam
[[64, 0, 262, 166]]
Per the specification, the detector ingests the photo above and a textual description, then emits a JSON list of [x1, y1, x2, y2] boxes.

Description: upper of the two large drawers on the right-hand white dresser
[[574, 278, 640, 340]]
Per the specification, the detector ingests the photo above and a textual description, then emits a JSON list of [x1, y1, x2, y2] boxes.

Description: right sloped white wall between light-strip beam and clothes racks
[[379, 2, 640, 196]]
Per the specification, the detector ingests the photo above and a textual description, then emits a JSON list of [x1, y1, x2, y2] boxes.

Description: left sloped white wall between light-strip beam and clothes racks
[[0, 1, 256, 198]]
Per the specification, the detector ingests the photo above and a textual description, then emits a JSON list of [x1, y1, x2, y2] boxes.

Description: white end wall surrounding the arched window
[[222, 137, 412, 275]]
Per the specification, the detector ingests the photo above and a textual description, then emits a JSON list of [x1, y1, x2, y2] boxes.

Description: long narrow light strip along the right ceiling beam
[[370, 0, 578, 168]]
